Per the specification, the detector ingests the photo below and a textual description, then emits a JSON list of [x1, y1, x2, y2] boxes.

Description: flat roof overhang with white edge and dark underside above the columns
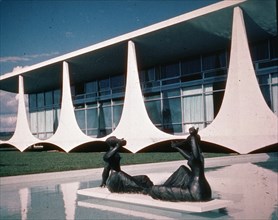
[[0, 0, 277, 93]]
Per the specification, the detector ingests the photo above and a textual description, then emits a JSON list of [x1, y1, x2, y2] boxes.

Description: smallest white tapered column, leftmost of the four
[[6, 76, 39, 151]]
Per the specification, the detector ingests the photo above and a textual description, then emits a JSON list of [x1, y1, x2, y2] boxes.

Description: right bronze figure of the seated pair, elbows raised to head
[[149, 127, 211, 201]]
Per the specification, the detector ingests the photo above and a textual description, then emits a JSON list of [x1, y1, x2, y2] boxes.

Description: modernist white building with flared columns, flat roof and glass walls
[[0, 0, 278, 154]]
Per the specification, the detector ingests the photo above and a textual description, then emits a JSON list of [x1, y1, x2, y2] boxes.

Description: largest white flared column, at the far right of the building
[[200, 7, 278, 154]]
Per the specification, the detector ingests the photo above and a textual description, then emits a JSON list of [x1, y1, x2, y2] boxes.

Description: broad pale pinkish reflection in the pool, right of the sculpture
[[207, 163, 278, 219]]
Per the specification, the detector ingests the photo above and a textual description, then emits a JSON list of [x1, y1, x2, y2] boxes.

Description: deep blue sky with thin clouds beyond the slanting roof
[[0, 0, 217, 132]]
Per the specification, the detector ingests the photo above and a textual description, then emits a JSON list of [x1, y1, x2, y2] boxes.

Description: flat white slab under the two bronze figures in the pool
[[77, 187, 232, 213]]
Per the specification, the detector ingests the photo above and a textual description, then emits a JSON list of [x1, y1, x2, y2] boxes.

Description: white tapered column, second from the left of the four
[[44, 61, 94, 152]]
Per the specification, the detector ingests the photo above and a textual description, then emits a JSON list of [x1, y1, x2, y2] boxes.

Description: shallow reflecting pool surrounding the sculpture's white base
[[0, 158, 278, 220]]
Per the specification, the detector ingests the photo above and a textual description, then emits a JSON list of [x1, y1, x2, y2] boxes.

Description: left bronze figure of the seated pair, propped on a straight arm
[[100, 136, 153, 194]]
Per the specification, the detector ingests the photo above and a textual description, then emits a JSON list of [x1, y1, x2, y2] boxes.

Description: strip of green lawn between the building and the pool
[[0, 150, 228, 177]]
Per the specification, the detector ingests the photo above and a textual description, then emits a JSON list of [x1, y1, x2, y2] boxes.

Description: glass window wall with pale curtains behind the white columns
[[29, 38, 278, 139]]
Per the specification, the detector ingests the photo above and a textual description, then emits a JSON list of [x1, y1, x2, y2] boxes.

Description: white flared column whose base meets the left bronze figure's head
[[109, 41, 177, 153]]
